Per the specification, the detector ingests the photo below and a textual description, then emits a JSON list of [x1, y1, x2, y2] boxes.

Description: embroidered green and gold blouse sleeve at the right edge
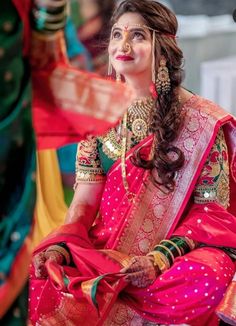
[[194, 129, 229, 208]]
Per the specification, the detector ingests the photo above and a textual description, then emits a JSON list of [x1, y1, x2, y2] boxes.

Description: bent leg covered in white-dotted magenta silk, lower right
[[123, 247, 235, 325]]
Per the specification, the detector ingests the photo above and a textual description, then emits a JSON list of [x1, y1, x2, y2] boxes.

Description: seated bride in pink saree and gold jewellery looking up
[[30, 0, 236, 325]]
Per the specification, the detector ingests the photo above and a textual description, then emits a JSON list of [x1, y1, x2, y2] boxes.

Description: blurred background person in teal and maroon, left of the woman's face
[[57, 0, 116, 205]]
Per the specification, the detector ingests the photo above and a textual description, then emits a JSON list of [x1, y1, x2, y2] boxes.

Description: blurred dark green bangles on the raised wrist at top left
[[32, 0, 67, 33]]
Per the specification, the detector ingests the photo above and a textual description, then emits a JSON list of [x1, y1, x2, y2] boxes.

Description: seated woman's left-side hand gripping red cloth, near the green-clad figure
[[33, 247, 64, 278]]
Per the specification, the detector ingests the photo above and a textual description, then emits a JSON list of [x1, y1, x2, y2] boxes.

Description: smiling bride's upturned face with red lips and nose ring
[[108, 13, 152, 77]]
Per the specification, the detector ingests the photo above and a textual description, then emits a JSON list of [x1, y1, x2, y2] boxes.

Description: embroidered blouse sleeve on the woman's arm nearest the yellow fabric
[[74, 136, 105, 190]]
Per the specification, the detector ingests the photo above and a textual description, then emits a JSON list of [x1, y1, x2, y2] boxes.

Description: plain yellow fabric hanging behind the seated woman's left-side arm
[[33, 150, 68, 247]]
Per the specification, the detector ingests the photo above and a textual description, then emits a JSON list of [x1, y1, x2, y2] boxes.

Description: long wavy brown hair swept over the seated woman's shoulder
[[111, 0, 185, 191]]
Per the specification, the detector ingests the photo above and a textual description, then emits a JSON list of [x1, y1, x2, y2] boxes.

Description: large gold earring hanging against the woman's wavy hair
[[156, 59, 170, 94]]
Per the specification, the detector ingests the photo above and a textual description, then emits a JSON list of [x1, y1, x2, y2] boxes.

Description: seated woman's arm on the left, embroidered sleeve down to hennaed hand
[[34, 137, 106, 278]]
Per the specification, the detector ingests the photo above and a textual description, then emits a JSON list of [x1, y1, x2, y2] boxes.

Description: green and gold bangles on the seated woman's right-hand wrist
[[147, 236, 196, 273]]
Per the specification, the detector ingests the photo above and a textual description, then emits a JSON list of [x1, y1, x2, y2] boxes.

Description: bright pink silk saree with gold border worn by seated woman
[[30, 96, 236, 326]]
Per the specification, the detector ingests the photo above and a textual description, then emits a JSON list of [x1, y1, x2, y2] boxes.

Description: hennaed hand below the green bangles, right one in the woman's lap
[[121, 256, 158, 288]]
